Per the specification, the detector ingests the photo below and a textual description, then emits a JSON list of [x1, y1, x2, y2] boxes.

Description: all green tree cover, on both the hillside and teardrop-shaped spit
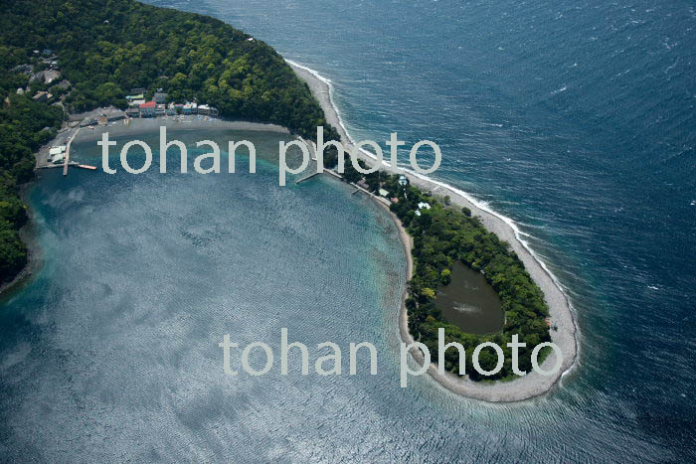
[[0, 0, 550, 380]]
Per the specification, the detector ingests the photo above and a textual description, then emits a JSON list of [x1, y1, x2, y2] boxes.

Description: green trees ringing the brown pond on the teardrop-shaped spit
[[344, 163, 550, 380]]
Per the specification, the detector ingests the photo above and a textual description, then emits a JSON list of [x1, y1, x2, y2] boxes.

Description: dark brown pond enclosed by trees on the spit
[[435, 262, 505, 335]]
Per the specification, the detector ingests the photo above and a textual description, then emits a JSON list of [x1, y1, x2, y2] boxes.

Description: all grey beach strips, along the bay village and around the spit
[[8, 60, 579, 403]]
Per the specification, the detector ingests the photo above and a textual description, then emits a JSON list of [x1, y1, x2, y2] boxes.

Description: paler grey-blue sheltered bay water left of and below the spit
[[0, 132, 680, 462]]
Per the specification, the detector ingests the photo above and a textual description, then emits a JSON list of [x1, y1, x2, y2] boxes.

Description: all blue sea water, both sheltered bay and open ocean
[[0, 0, 696, 463]]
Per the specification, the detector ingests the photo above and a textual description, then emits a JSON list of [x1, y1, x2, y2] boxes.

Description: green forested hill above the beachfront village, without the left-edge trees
[[0, 0, 338, 137]]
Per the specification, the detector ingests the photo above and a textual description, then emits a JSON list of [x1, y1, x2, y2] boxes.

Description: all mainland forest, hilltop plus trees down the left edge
[[0, 0, 338, 282]]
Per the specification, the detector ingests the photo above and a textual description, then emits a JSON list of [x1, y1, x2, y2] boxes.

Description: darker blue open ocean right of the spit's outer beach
[[147, 0, 696, 462]]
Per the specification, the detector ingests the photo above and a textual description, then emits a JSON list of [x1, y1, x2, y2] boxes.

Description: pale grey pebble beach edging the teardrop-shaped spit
[[286, 60, 580, 403]]
